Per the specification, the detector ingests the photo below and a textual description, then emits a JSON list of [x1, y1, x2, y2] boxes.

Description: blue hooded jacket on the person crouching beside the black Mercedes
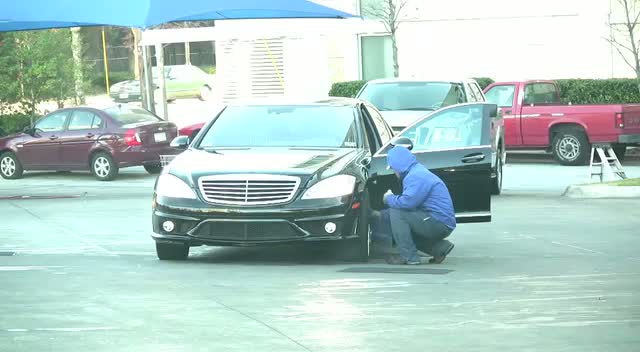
[[386, 146, 456, 229]]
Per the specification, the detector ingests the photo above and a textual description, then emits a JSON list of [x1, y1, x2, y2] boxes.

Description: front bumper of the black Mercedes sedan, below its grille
[[152, 197, 358, 246]]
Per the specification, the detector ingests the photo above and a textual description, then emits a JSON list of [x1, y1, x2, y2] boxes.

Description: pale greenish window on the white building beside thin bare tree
[[360, 35, 393, 81]]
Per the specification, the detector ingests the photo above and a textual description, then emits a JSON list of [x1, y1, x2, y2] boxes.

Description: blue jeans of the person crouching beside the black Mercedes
[[369, 209, 453, 261]]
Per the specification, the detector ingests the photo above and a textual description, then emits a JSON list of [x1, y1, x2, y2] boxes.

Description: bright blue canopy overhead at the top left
[[0, 0, 355, 32]]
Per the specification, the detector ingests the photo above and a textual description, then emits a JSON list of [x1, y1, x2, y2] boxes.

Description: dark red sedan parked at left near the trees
[[0, 105, 177, 181]]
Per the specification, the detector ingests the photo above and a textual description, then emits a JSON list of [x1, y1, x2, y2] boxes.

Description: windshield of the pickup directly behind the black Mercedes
[[358, 82, 466, 111]]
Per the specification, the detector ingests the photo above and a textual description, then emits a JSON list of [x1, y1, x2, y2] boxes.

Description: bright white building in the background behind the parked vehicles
[[150, 0, 633, 102]]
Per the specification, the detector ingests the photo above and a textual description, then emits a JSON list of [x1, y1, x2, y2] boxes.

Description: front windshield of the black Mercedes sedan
[[198, 106, 357, 149]]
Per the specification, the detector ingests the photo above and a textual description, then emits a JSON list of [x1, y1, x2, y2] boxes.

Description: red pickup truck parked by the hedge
[[484, 81, 640, 165]]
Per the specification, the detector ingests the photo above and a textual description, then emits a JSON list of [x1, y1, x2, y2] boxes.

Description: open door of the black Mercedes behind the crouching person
[[369, 103, 497, 223]]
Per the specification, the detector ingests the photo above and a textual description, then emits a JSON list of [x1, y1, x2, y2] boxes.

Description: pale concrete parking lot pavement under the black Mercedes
[[0, 156, 640, 352]]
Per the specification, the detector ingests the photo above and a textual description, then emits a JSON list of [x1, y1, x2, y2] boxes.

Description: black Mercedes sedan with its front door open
[[152, 98, 497, 261]]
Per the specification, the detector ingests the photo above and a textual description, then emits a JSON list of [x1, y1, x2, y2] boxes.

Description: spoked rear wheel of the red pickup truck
[[552, 127, 591, 166]]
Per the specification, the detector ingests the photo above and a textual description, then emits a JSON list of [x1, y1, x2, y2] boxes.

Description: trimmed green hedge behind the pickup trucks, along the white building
[[329, 77, 640, 105]]
